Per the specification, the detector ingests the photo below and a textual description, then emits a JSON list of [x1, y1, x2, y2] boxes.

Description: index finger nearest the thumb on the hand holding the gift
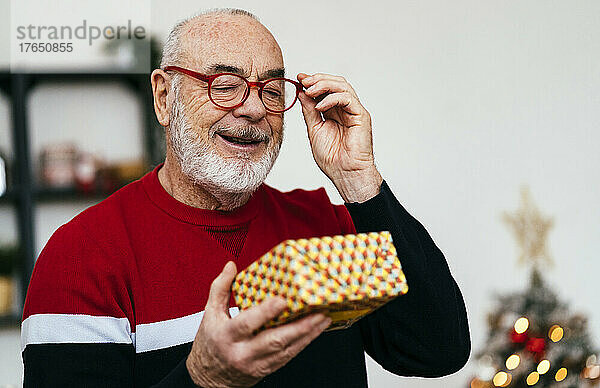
[[230, 297, 287, 339]]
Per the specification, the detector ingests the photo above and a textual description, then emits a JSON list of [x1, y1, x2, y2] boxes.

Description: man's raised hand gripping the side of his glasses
[[298, 73, 383, 202]]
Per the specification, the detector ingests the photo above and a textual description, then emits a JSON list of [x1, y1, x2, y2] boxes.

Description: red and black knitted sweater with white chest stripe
[[22, 164, 469, 387]]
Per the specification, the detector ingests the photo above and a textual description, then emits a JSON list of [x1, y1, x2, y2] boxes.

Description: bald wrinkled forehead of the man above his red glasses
[[182, 15, 283, 78]]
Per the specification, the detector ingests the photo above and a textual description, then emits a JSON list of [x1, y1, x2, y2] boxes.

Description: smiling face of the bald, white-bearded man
[[169, 15, 283, 192]]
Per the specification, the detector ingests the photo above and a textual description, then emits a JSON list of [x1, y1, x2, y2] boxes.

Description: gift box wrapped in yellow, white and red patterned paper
[[232, 231, 408, 330]]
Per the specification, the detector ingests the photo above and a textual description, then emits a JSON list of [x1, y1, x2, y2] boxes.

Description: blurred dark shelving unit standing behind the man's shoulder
[[0, 72, 164, 327]]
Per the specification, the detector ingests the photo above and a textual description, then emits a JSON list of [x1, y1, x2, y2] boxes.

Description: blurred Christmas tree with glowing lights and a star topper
[[470, 189, 600, 388]]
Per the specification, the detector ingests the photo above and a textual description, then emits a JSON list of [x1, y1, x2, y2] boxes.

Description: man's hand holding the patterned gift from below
[[186, 261, 331, 388]]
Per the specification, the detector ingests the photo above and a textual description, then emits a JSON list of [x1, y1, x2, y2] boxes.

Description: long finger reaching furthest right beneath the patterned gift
[[252, 313, 331, 358]]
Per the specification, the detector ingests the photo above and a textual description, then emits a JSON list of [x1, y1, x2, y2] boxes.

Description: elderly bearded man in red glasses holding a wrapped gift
[[22, 9, 470, 387]]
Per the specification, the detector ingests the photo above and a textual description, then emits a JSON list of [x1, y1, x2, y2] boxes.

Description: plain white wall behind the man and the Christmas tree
[[0, 0, 600, 387]]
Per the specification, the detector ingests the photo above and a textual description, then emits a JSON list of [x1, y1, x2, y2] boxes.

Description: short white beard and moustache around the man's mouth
[[169, 83, 283, 194]]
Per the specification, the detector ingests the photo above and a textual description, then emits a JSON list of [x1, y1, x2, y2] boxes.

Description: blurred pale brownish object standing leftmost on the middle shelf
[[40, 143, 77, 188]]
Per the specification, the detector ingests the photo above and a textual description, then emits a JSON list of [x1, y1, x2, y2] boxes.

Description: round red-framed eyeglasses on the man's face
[[163, 66, 302, 113]]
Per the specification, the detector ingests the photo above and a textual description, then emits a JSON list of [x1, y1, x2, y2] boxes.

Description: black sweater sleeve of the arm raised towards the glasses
[[345, 181, 471, 377]]
